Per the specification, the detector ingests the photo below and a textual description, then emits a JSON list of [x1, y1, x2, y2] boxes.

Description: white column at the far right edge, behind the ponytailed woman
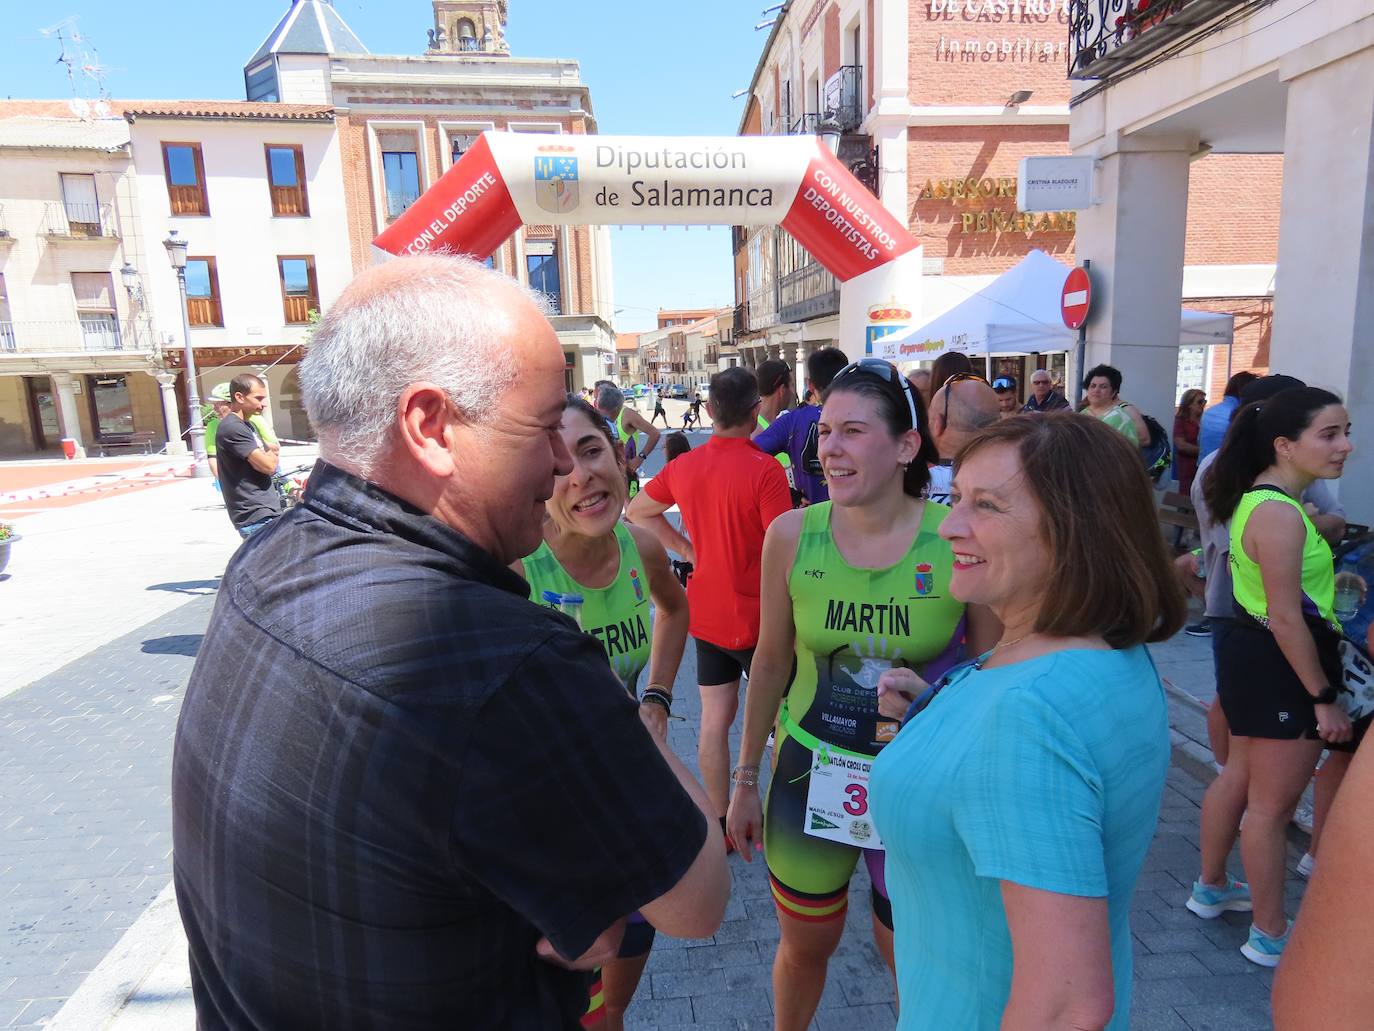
[[1270, 32, 1374, 522]]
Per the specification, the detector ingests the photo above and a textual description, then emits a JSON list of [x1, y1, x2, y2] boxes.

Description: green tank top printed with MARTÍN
[[783, 500, 965, 756]]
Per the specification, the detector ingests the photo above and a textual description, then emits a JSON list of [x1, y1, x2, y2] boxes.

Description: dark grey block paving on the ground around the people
[[0, 445, 1303, 1031]]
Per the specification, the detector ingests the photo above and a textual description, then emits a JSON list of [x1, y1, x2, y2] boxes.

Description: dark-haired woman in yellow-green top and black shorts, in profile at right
[[1187, 386, 1352, 966]]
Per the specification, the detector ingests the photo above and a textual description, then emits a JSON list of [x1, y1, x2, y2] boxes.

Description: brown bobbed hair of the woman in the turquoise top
[[955, 412, 1187, 647]]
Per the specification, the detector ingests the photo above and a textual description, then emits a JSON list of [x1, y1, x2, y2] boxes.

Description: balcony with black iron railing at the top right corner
[[1069, 0, 1272, 78]]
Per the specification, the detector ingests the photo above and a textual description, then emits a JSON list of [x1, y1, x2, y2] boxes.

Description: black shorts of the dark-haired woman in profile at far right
[[1216, 617, 1370, 752]]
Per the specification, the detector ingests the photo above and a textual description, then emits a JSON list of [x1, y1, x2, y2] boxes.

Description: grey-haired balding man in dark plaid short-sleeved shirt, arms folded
[[172, 257, 730, 1031]]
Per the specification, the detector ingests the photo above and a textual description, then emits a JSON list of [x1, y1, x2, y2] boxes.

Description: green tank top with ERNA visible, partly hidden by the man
[[523, 522, 650, 697]]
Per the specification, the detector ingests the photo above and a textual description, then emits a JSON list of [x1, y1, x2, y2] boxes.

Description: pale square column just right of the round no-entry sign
[[1066, 133, 1197, 426]]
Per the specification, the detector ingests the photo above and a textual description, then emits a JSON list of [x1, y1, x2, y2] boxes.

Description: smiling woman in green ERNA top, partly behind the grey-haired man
[[515, 395, 687, 1031]]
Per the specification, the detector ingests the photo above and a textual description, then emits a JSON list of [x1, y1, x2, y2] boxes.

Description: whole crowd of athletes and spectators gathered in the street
[[173, 257, 1371, 1031]]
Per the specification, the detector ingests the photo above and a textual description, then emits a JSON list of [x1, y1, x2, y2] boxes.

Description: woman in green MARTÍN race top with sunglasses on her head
[[727, 359, 996, 1027]]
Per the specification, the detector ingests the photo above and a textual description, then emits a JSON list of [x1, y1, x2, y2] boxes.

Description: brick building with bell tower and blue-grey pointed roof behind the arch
[[245, 0, 617, 389]]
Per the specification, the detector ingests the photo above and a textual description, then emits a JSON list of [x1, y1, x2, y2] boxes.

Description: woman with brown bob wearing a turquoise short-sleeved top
[[871, 415, 1186, 1031]]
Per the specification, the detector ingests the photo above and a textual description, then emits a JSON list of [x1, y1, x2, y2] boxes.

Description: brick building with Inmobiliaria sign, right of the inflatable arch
[[734, 0, 1282, 419]]
